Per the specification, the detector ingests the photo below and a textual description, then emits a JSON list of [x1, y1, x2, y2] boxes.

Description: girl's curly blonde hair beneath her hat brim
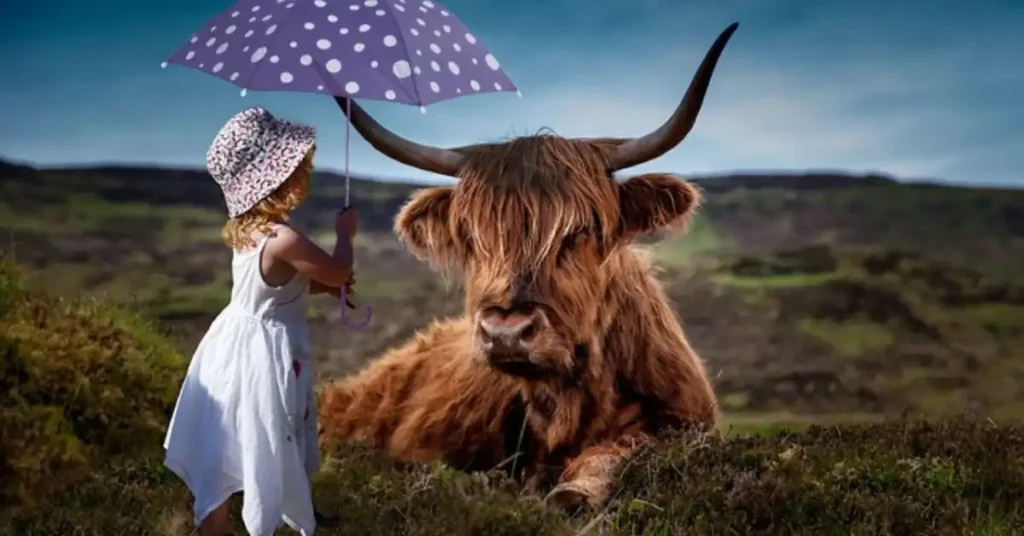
[[220, 146, 316, 249]]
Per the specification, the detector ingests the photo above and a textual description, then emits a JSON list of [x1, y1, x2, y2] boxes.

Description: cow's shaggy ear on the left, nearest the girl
[[394, 187, 455, 264]]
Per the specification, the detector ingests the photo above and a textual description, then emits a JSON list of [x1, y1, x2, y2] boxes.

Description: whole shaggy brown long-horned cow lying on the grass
[[321, 24, 737, 505]]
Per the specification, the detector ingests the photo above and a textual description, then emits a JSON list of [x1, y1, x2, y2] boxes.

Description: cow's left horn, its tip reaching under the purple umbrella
[[334, 96, 465, 177]]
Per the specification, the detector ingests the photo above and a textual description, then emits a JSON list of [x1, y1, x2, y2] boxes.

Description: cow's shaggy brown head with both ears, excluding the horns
[[395, 136, 698, 378]]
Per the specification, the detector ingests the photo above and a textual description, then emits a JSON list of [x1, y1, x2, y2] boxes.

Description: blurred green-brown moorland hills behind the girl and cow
[[0, 155, 1024, 423]]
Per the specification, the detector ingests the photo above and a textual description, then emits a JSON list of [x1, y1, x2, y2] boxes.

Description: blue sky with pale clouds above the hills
[[0, 0, 1024, 188]]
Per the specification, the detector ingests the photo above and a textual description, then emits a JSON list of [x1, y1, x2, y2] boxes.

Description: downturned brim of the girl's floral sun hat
[[228, 118, 316, 217]]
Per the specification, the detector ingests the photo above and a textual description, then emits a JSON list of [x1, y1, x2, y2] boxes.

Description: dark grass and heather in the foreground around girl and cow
[[0, 254, 1024, 536]]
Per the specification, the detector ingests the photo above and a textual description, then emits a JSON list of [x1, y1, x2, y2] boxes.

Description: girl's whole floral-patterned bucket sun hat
[[206, 107, 316, 217]]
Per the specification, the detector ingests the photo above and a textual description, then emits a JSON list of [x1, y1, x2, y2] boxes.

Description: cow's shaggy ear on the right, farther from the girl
[[618, 173, 700, 238]]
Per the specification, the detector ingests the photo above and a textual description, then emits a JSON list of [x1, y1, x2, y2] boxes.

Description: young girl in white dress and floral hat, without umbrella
[[164, 108, 356, 536]]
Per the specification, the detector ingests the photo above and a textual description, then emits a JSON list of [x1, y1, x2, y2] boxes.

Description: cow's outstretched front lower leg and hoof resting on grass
[[544, 434, 651, 508]]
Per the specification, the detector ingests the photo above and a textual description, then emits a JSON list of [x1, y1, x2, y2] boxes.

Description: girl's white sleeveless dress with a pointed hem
[[164, 225, 321, 536]]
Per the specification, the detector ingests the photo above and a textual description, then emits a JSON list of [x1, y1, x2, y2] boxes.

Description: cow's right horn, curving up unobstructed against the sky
[[610, 23, 739, 170]]
